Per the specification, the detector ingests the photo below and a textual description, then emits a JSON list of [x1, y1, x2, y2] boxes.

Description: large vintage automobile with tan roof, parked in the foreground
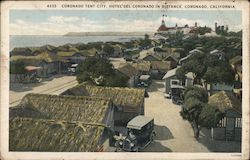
[[114, 115, 156, 152]]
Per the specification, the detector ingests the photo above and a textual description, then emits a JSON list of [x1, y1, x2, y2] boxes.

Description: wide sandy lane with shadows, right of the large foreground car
[[144, 81, 241, 152]]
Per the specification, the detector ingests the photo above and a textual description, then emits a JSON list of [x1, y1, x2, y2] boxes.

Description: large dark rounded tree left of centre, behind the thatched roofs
[[76, 58, 128, 87]]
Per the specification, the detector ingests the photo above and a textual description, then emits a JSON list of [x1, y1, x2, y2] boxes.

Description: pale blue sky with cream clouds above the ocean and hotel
[[10, 10, 242, 35]]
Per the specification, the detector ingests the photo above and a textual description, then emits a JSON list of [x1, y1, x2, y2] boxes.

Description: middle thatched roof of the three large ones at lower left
[[10, 94, 111, 123]]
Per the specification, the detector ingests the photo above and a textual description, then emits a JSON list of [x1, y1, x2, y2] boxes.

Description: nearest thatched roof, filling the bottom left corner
[[9, 117, 105, 152]]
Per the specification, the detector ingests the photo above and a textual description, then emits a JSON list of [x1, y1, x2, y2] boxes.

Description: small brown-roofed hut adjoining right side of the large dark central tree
[[117, 63, 139, 87]]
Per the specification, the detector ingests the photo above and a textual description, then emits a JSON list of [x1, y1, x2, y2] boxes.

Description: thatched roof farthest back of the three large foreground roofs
[[62, 84, 145, 107]]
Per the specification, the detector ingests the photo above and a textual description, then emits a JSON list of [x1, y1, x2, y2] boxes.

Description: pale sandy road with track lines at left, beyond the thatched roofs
[[9, 75, 78, 107]]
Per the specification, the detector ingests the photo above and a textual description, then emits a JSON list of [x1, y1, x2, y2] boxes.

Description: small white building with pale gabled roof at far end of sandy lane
[[162, 67, 194, 96]]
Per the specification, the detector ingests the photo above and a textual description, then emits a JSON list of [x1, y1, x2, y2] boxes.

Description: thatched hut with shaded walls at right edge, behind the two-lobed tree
[[208, 91, 242, 141]]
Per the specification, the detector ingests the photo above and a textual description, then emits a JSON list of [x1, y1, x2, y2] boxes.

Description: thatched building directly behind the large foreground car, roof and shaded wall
[[62, 84, 145, 134]]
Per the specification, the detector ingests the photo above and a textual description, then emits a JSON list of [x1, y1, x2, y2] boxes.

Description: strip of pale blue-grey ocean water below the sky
[[10, 35, 144, 50]]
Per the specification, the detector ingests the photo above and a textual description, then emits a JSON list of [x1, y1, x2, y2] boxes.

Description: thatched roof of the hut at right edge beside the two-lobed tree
[[208, 91, 242, 113]]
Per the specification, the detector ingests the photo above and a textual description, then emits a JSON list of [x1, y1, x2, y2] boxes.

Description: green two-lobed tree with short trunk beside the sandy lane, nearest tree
[[180, 86, 222, 138]]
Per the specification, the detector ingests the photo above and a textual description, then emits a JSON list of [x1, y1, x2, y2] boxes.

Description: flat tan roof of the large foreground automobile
[[127, 116, 153, 130]]
